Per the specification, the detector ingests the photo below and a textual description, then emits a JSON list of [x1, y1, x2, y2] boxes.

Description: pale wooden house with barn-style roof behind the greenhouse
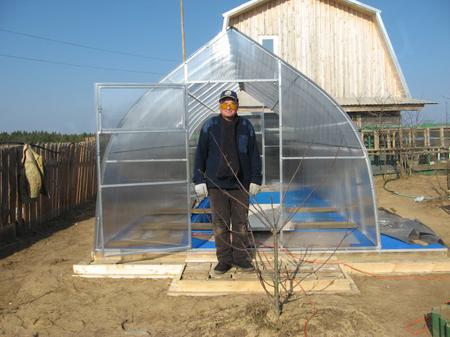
[[223, 0, 427, 127]]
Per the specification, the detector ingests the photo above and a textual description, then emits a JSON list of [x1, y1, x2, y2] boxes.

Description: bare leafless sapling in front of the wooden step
[[198, 135, 355, 318]]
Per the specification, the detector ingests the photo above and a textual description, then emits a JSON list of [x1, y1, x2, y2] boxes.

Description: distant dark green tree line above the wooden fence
[[0, 131, 94, 144]]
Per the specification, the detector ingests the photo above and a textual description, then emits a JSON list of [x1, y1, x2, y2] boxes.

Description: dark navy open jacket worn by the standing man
[[193, 116, 262, 189]]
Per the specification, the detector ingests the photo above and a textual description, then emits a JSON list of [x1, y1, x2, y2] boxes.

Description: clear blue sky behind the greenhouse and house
[[0, 0, 450, 133]]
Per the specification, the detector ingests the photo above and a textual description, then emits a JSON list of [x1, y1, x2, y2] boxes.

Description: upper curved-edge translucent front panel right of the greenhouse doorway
[[281, 65, 364, 157]]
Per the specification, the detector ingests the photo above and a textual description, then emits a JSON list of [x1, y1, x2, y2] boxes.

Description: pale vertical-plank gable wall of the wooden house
[[229, 0, 405, 98]]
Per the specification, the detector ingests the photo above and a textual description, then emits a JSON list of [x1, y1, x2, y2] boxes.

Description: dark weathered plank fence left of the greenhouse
[[0, 141, 97, 240]]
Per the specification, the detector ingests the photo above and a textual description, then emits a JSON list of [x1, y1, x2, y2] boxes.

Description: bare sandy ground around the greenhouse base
[[0, 176, 450, 337]]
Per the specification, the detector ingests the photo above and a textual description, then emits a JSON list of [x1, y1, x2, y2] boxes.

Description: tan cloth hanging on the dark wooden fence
[[20, 144, 47, 201]]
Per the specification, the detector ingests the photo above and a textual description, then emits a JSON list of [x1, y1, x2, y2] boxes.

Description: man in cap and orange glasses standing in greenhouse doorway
[[193, 90, 262, 274]]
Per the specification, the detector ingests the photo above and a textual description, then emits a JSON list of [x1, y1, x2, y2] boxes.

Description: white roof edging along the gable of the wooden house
[[222, 0, 411, 97]]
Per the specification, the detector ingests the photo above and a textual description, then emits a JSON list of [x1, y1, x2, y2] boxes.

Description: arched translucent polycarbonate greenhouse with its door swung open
[[94, 28, 380, 255]]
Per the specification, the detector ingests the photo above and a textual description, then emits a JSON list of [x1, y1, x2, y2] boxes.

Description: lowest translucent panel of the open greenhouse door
[[102, 184, 189, 250]]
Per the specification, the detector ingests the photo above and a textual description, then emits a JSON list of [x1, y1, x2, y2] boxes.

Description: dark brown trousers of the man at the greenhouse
[[208, 188, 251, 264]]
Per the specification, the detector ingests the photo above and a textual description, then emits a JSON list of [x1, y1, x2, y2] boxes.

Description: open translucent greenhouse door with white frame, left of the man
[[96, 84, 191, 253]]
